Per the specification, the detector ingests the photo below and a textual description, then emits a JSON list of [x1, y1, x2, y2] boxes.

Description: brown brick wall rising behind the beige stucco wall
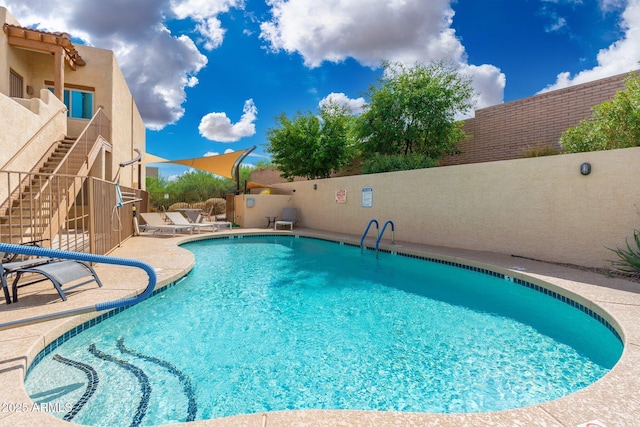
[[440, 73, 629, 165]]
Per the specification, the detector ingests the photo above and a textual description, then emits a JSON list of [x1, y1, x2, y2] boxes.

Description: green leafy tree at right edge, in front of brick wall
[[560, 72, 640, 153]]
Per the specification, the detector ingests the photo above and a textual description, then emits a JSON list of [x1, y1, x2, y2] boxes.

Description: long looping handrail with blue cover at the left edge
[[0, 243, 157, 330]]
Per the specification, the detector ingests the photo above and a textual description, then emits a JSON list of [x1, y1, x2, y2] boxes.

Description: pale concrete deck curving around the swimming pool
[[0, 229, 640, 427]]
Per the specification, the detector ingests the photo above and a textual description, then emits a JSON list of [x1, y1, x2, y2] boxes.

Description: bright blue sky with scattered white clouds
[[0, 0, 640, 178]]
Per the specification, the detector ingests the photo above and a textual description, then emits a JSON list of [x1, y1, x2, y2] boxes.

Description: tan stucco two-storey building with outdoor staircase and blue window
[[0, 7, 145, 252]]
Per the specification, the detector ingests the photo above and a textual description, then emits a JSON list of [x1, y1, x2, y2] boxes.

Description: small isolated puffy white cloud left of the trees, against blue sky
[[198, 99, 258, 142]]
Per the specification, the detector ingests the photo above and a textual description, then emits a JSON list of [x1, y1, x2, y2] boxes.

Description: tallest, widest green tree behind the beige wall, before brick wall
[[356, 61, 473, 170]]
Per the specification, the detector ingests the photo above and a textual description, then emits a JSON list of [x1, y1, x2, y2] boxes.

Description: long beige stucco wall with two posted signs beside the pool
[[255, 147, 640, 267]]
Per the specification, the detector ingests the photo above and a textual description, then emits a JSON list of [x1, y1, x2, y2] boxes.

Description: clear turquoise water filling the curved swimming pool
[[26, 236, 622, 426]]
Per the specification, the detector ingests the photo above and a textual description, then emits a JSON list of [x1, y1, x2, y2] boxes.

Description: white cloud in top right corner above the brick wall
[[539, 0, 640, 93]]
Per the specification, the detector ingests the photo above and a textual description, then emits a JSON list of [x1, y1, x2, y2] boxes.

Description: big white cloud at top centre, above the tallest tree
[[260, 0, 505, 114]]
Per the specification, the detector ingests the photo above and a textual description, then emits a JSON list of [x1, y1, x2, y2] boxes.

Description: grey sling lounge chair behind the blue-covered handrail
[[0, 258, 102, 304]]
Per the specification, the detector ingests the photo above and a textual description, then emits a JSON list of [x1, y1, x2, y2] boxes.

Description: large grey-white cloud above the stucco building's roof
[[0, 0, 244, 130]]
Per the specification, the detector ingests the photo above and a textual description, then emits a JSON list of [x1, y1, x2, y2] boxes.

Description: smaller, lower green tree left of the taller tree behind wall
[[267, 103, 353, 181]]
